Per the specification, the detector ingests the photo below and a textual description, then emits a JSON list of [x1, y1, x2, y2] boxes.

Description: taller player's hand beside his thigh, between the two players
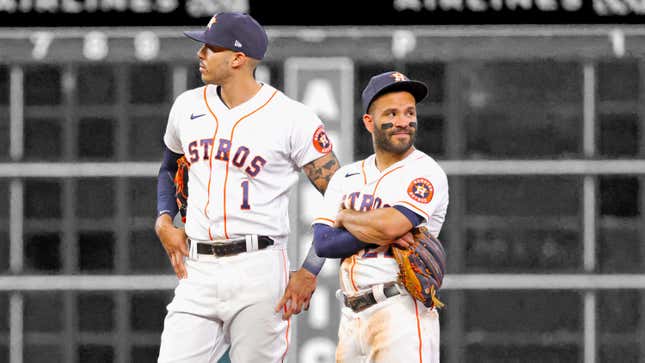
[[275, 267, 316, 320]]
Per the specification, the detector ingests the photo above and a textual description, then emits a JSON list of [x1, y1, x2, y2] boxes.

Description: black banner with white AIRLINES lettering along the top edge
[[0, 0, 645, 27]]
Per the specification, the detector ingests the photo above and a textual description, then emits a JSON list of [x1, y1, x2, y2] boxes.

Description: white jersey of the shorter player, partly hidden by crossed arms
[[313, 150, 448, 295]]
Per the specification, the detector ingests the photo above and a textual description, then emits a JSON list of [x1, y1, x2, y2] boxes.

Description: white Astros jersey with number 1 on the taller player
[[164, 84, 332, 244]]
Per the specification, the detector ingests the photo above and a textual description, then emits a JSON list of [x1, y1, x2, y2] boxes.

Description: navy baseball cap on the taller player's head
[[184, 12, 269, 60]]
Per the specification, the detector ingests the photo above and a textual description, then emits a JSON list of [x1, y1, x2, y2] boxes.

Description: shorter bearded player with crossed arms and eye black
[[314, 72, 448, 363]]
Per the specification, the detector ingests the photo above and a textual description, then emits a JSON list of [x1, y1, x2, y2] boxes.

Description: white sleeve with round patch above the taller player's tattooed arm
[[290, 106, 332, 168]]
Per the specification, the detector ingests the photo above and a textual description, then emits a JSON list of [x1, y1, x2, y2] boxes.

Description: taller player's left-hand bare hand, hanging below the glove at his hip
[[155, 214, 188, 279]]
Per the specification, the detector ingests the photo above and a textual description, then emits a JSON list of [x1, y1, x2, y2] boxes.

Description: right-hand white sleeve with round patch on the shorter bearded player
[[388, 167, 448, 228]]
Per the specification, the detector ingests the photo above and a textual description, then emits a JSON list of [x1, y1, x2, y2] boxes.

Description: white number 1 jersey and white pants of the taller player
[[158, 84, 332, 363]]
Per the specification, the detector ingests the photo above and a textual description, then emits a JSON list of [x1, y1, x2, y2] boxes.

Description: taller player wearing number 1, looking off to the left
[[155, 13, 338, 363]]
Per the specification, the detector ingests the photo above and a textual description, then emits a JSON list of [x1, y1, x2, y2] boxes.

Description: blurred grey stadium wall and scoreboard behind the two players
[[0, 0, 645, 363]]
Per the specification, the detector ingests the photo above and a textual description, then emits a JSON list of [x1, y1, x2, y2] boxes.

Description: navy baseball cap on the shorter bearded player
[[361, 71, 428, 113]]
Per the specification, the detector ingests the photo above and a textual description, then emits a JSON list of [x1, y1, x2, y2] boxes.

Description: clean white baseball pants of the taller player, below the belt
[[158, 247, 290, 363]]
